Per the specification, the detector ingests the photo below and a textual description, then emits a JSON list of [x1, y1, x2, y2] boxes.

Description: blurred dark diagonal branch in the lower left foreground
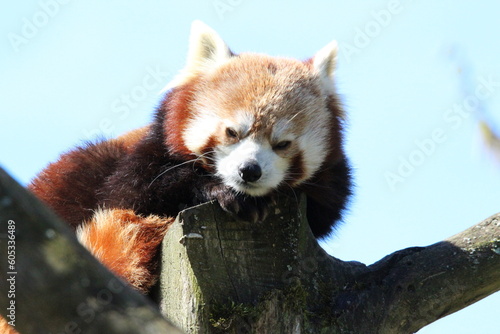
[[0, 168, 181, 334]]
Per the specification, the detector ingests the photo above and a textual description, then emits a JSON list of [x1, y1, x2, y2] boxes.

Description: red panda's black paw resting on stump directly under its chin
[[216, 191, 276, 223]]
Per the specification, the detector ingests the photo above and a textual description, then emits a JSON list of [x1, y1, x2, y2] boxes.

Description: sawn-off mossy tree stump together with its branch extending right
[[160, 197, 500, 334]]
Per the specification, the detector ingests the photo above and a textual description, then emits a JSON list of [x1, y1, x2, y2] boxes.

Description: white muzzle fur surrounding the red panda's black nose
[[215, 138, 289, 196]]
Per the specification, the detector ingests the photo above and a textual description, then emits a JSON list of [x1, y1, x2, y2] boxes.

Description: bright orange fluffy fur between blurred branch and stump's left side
[[76, 209, 174, 293]]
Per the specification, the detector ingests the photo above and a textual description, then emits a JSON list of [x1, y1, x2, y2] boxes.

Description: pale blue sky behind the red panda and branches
[[0, 0, 500, 334]]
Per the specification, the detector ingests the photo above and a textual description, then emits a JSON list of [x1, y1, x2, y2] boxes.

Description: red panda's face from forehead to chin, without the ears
[[183, 54, 333, 196]]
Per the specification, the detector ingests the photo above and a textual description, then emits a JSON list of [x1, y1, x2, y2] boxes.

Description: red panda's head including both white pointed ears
[[166, 22, 342, 196]]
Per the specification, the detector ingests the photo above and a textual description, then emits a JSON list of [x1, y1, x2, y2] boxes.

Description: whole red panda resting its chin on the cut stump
[[29, 22, 351, 292]]
